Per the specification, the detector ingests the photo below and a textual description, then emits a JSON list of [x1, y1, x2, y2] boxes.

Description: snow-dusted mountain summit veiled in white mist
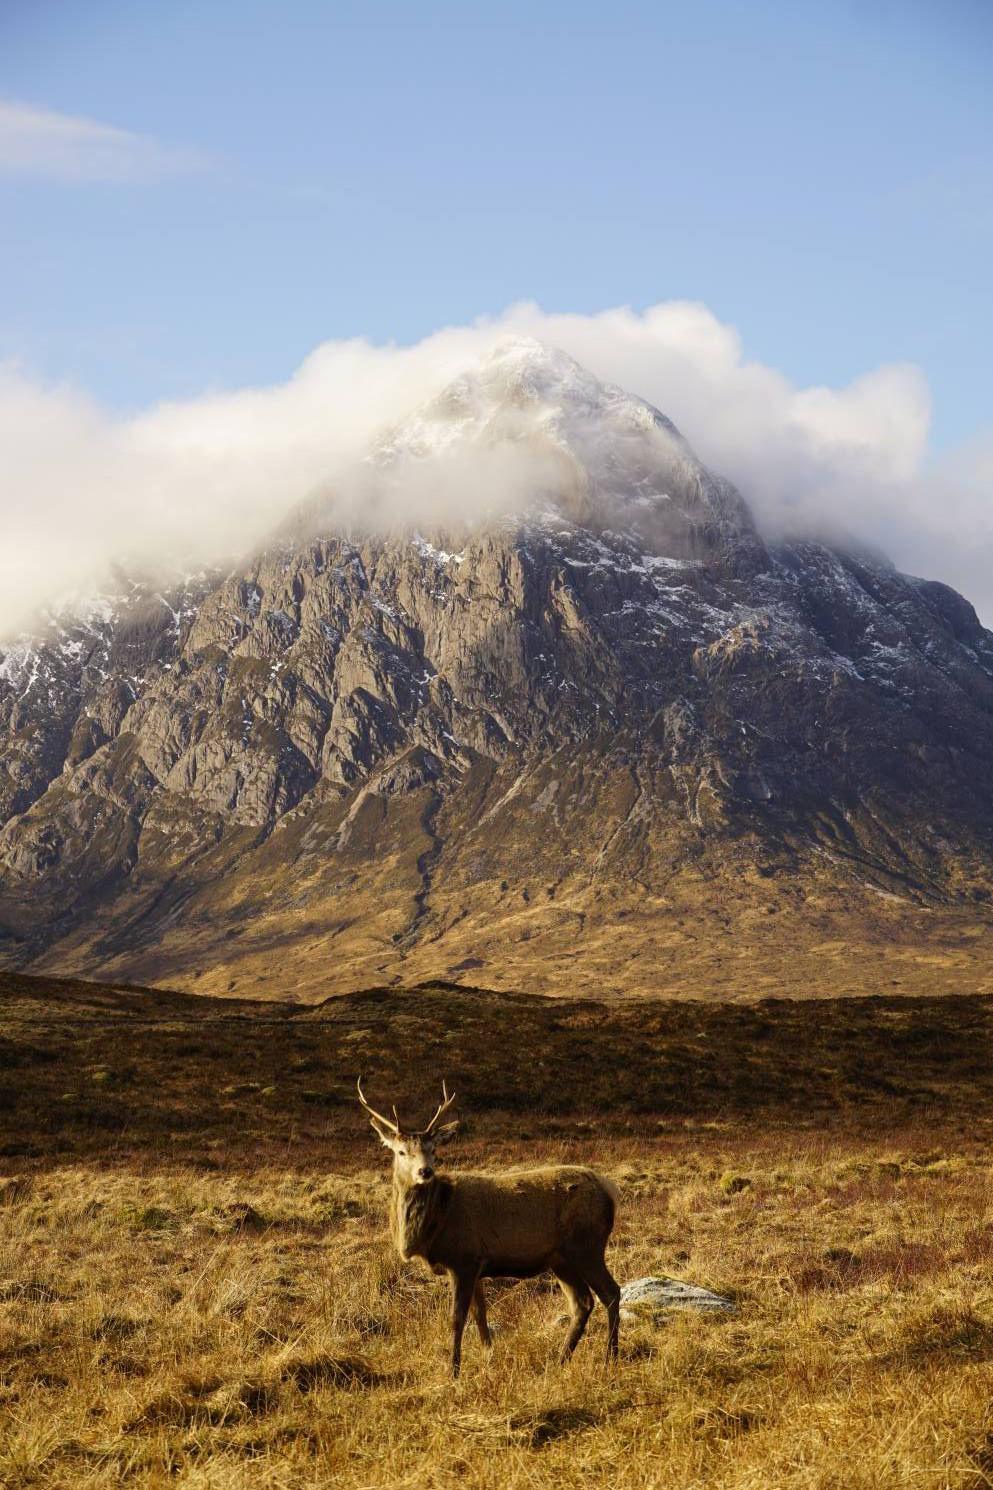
[[370, 337, 760, 559]]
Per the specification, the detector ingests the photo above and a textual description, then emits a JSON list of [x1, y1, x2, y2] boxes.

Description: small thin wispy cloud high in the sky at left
[[0, 98, 206, 185]]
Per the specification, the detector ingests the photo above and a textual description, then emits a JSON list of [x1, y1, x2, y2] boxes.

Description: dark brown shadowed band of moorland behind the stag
[[0, 974, 993, 1168]]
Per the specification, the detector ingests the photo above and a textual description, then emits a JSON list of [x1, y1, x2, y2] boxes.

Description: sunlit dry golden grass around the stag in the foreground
[[0, 1129, 993, 1490]]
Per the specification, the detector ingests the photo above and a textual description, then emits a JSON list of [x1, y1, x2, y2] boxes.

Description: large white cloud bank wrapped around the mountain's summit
[[0, 302, 993, 633]]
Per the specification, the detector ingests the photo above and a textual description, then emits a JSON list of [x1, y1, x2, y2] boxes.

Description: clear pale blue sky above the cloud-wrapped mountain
[[0, 0, 993, 450]]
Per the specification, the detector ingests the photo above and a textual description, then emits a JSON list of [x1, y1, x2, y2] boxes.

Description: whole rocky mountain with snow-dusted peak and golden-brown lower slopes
[[0, 341, 993, 998]]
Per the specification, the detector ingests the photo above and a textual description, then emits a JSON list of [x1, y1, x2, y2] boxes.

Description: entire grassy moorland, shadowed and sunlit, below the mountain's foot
[[0, 977, 993, 1490]]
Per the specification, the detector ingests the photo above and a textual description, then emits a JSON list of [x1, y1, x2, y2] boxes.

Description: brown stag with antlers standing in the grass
[[358, 1077, 620, 1377]]
